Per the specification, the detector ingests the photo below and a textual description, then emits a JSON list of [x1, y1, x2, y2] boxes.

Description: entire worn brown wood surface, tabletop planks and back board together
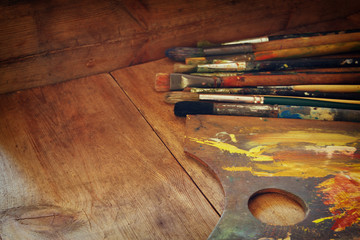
[[0, 0, 360, 240]]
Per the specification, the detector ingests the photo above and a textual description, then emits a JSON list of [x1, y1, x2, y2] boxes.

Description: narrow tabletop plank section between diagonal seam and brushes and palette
[[111, 59, 224, 213]]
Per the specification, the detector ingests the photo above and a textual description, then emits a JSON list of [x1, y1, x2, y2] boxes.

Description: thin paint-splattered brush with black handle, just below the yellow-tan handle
[[181, 87, 360, 100]]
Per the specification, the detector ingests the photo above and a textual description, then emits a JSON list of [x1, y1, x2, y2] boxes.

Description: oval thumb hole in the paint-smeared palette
[[248, 188, 308, 226]]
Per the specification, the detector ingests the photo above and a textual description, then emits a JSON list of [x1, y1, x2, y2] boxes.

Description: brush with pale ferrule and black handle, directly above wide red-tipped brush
[[174, 58, 360, 73]]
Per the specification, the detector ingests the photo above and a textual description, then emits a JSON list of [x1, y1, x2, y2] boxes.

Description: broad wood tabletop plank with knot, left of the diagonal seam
[[0, 74, 219, 240]]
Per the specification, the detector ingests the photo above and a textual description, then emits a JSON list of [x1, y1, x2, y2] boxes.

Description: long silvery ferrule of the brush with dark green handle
[[199, 94, 264, 104]]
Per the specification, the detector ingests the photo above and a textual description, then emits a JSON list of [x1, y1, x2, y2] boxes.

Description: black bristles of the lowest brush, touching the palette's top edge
[[174, 102, 214, 117]]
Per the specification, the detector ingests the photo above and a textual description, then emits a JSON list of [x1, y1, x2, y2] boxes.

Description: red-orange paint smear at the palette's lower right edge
[[319, 174, 360, 231]]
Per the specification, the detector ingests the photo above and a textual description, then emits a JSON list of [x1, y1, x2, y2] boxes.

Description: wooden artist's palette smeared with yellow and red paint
[[184, 115, 360, 240]]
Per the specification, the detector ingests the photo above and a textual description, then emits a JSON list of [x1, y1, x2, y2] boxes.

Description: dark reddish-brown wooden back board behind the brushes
[[0, 0, 360, 93]]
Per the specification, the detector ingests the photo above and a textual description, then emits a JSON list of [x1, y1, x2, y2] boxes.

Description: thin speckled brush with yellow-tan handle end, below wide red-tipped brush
[[186, 84, 360, 94]]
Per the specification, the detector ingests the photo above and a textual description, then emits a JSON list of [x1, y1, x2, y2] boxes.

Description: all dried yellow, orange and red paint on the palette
[[188, 129, 360, 232]]
